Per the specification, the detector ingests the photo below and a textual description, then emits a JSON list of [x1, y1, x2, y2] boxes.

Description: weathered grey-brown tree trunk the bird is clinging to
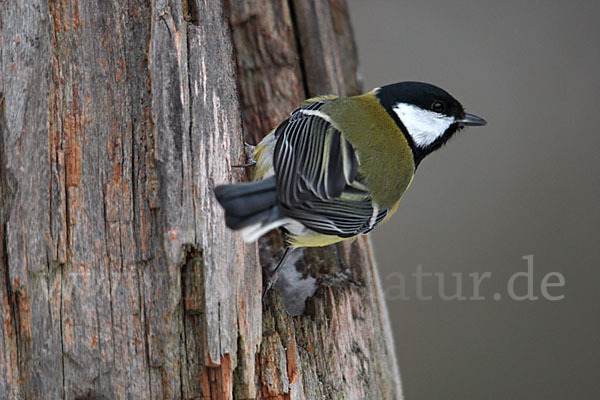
[[0, 0, 401, 399]]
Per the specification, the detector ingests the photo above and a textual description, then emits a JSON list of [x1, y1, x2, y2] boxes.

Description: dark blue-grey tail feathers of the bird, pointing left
[[215, 177, 281, 230]]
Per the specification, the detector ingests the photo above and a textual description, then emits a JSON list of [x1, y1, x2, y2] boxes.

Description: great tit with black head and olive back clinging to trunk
[[215, 82, 486, 250]]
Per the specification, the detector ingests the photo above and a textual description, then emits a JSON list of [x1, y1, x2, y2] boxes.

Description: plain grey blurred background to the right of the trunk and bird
[[349, 0, 600, 400]]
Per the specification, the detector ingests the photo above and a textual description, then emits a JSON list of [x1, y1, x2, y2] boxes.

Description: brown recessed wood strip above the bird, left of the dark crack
[[227, 0, 307, 143]]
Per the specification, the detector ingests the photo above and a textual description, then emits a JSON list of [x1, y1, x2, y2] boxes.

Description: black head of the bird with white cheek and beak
[[375, 82, 486, 165]]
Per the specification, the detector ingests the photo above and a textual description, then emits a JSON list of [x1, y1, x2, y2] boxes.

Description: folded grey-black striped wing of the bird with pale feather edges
[[273, 100, 389, 237]]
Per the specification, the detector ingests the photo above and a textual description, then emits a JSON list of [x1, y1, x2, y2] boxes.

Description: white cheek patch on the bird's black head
[[393, 103, 454, 147]]
